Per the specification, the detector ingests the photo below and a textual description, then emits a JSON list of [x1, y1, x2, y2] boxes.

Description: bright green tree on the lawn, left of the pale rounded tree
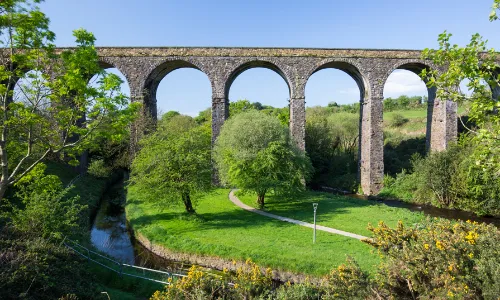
[[130, 115, 212, 213]]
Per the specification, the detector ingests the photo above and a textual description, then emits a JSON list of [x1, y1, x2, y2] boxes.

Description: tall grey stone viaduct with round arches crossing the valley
[[92, 47, 457, 194]]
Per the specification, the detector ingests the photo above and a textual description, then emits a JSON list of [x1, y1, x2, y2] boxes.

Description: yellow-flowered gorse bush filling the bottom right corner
[[365, 219, 500, 299]]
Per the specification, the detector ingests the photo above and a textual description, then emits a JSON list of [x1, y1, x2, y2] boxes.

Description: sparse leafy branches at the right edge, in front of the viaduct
[[421, 0, 500, 177]]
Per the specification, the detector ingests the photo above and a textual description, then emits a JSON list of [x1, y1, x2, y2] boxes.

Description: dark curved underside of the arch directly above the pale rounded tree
[[224, 59, 293, 99]]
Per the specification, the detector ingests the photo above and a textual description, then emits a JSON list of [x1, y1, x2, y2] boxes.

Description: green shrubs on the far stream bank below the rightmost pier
[[381, 137, 500, 216]]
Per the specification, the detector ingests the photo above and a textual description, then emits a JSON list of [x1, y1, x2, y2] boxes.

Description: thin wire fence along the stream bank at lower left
[[63, 238, 186, 285]]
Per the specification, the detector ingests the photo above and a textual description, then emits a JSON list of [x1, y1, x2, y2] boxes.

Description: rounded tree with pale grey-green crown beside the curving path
[[214, 111, 312, 208]]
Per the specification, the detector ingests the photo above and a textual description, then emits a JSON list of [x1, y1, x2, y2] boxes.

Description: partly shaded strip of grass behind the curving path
[[237, 191, 425, 236]]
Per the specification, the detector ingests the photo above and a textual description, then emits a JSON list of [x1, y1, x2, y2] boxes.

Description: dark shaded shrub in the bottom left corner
[[0, 227, 98, 299]]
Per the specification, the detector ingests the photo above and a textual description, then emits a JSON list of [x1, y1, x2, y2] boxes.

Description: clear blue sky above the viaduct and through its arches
[[40, 0, 500, 115]]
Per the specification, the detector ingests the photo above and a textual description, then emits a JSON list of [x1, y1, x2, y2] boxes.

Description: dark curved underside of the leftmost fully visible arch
[[142, 59, 213, 120]]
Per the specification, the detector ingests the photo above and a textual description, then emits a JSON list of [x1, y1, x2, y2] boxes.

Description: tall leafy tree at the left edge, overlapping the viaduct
[[0, 0, 138, 201]]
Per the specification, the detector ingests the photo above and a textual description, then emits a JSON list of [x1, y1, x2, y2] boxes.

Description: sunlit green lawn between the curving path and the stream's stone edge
[[126, 188, 379, 275]]
